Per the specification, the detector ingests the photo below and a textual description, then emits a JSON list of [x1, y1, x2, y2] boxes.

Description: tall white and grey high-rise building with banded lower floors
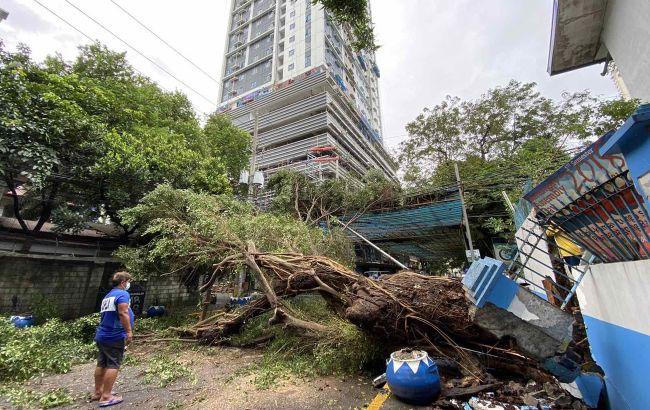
[[219, 0, 396, 183]]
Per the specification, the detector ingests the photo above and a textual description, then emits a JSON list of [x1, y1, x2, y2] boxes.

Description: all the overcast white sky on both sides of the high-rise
[[0, 0, 615, 147]]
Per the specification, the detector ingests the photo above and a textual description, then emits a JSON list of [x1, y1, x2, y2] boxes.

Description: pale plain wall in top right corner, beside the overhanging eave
[[602, 0, 650, 102]]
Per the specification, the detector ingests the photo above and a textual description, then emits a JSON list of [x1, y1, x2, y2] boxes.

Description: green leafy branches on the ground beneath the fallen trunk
[[231, 296, 385, 388]]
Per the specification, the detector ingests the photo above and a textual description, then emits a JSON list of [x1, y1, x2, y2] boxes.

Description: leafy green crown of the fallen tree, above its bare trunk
[[117, 184, 351, 277]]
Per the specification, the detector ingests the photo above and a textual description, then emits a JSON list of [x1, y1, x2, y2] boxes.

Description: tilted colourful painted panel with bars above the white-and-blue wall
[[524, 133, 650, 262]]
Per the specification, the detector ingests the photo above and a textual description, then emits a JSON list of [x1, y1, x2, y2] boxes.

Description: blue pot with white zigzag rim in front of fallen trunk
[[386, 350, 440, 404]]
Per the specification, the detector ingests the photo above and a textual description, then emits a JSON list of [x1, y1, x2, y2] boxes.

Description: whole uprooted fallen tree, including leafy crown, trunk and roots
[[120, 186, 588, 406]]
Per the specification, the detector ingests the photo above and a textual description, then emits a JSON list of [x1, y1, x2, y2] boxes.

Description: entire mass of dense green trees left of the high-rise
[[0, 44, 250, 237]]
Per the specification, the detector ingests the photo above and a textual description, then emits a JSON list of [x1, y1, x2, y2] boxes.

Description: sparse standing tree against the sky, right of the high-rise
[[399, 80, 639, 253]]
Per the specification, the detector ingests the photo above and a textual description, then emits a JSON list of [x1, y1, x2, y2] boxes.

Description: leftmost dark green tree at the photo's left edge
[[0, 44, 102, 231]]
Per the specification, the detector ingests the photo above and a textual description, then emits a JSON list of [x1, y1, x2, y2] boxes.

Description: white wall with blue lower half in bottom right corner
[[577, 260, 650, 409]]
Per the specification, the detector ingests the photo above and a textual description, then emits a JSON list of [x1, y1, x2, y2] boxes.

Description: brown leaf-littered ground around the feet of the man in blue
[[7, 342, 384, 410]]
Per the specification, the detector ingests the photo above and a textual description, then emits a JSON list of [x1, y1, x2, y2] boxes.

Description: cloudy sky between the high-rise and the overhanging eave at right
[[371, 0, 616, 147]]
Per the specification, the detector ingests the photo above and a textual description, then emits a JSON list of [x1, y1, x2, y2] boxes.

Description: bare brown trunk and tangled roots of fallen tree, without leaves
[[194, 243, 548, 382]]
